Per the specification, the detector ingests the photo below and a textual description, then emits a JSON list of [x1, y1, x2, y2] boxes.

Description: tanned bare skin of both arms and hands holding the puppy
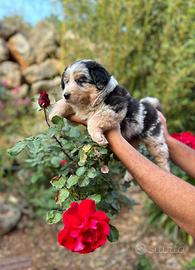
[[67, 114, 195, 238]]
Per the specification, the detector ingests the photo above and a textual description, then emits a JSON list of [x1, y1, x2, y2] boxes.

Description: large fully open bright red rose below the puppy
[[58, 199, 110, 254]]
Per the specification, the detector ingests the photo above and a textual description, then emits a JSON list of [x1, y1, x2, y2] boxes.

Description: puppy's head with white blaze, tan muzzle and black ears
[[61, 60, 111, 106]]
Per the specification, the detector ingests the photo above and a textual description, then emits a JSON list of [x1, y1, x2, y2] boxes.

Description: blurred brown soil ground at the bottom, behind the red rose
[[0, 190, 195, 270]]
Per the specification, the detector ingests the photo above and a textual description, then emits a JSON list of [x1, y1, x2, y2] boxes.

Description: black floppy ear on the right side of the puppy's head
[[85, 61, 111, 90]]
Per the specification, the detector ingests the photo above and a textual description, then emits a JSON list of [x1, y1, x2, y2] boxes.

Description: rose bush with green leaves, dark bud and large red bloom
[[8, 93, 134, 253]]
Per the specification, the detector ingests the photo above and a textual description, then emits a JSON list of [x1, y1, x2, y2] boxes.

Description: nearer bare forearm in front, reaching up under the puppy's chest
[[106, 130, 195, 237]]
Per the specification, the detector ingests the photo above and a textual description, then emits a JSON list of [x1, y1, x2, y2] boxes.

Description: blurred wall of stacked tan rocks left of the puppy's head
[[0, 21, 63, 96]]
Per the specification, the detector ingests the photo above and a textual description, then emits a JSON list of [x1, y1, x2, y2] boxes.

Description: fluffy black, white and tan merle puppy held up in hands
[[50, 60, 169, 170]]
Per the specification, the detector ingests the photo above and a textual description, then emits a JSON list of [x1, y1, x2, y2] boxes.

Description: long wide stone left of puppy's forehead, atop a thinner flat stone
[[23, 59, 61, 84]]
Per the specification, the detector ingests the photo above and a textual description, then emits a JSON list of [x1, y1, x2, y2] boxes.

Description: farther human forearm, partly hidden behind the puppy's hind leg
[[166, 135, 195, 178]]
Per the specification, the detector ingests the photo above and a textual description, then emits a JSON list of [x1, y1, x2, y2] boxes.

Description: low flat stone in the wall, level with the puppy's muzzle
[[31, 76, 61, 95]]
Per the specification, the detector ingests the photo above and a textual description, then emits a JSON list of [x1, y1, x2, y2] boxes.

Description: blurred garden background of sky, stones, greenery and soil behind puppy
[[0, 0, 195, 270]]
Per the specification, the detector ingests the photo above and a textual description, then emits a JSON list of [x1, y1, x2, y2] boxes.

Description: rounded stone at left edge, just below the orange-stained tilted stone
[[0, 61, 21, 88]]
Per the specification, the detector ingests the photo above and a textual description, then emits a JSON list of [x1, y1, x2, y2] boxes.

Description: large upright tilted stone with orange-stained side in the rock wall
[[7, 33, 34, 69]]
